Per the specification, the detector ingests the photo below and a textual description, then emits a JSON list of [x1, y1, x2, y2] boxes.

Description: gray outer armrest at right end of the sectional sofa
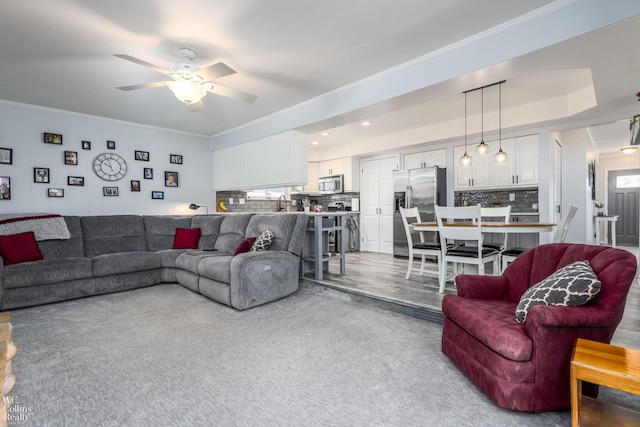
[[229, 250, 300, 310]]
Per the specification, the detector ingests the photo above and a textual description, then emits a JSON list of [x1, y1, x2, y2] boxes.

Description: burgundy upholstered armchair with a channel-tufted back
[[442, 243, 637, 412]]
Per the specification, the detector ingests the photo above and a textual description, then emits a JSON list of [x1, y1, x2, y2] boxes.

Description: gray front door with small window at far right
[[608, 169, 640, 246]]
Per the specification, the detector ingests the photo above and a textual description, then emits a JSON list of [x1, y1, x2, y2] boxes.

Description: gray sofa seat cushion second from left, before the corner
[[91, 251, 162, 277]]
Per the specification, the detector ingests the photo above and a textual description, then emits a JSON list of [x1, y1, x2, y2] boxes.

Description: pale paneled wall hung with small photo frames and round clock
[[0, 101, 215, 215]]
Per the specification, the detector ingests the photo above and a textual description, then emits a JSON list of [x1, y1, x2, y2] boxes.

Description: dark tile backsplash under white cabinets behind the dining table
[[454, 189, 538, 213]]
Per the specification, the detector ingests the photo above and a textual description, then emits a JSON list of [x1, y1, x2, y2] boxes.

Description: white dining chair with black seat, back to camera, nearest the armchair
[[435, 205, 499, 292]]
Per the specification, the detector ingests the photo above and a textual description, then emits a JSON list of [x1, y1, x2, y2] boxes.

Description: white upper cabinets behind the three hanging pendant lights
[[454, 135, 538, 190]]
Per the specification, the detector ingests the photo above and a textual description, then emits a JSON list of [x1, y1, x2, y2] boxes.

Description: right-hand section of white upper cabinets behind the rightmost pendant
[[493, 135, 538, 187]]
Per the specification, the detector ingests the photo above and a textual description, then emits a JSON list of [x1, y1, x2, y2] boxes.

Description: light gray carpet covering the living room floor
[[2, 285, 616, 427]]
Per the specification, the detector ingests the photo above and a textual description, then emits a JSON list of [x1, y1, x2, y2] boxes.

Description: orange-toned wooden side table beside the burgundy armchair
[[571, 338, 640, 427]]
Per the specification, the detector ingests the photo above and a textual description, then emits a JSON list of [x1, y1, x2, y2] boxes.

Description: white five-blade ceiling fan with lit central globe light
[[115, 47, 257, 111]]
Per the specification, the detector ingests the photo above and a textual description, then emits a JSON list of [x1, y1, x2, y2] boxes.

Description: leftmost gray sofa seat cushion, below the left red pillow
[[2, 258, 92, 289]]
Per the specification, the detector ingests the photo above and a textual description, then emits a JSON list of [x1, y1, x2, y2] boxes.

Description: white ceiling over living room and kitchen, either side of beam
[[0, 0, 640, 155]]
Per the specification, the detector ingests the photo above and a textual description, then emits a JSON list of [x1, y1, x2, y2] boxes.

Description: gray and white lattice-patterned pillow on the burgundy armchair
[[516, 261, 601, 323]]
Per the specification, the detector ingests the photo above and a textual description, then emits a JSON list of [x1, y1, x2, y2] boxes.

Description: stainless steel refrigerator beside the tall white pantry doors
[[393, 166, 447, 257]]
